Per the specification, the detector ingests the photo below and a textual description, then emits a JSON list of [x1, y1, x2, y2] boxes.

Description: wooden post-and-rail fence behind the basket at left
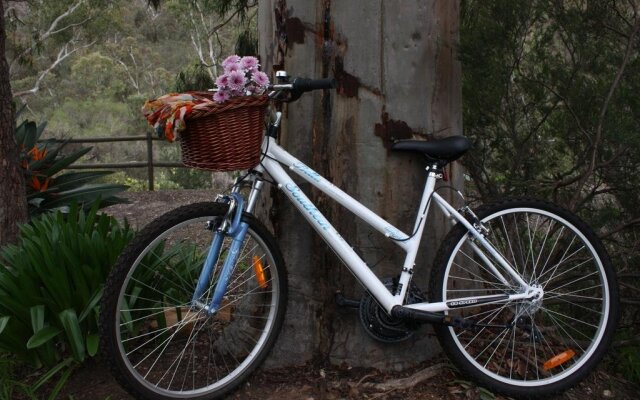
[[47, 133, 186, 190]]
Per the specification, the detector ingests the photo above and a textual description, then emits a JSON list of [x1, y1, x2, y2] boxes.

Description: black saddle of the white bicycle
[[391, 136, 471, 162]]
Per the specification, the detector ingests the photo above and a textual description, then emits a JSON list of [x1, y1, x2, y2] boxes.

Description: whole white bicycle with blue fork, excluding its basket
[[101, 73, 619, 399]]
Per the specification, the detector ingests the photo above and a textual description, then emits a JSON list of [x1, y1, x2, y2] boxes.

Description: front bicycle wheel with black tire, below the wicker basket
[[100, 203, 287, 399]]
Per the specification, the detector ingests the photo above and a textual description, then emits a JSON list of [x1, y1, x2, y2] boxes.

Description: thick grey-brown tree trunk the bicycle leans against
[[258, 0, 462, 368]]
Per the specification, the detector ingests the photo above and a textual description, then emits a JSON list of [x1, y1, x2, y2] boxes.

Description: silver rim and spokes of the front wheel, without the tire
[[115, 216, 280, 398]]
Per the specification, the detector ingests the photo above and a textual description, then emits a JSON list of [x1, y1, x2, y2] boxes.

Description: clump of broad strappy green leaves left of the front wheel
[[0, 205, 134, 367]]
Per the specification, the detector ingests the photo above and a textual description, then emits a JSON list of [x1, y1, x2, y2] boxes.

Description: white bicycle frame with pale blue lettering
[[247, 136, 541, 313]]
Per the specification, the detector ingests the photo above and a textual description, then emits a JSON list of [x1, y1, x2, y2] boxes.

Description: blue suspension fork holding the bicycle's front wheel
[[191, 193, 249, 314]]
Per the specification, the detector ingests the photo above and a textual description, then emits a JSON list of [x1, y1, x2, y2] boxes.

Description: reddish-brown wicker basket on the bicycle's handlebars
[[180, 93, 268, 171]]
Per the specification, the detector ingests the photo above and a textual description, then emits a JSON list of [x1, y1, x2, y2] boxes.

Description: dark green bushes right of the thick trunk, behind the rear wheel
[[460, 0, 640, 377]]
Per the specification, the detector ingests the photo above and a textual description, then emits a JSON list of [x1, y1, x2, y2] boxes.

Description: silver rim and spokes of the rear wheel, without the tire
[[443, 208, 610, 386]]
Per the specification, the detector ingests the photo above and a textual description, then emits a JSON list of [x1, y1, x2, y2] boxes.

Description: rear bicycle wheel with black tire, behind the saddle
[[431, 199, 619, 398]]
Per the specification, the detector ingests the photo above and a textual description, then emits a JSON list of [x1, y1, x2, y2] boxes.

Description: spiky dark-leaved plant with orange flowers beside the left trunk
[[16, 115, 126, 215]]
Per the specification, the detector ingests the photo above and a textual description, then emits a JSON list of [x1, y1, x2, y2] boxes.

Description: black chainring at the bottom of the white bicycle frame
[[359, 277, 425, 343]]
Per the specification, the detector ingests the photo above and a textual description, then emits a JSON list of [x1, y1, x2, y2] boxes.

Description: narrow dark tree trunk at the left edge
[[0, 2, 27, 246]]
